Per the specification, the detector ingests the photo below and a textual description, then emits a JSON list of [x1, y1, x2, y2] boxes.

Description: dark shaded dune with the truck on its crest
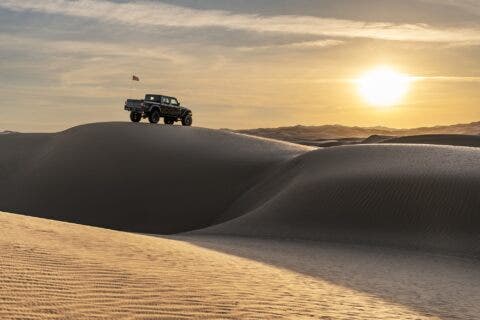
[[0, 123, 309, 233]]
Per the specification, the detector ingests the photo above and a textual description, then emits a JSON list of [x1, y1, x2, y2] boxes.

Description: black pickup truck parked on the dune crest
[[125, 94, 193, 126]]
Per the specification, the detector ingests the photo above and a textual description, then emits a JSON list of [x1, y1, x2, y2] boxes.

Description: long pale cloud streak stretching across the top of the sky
[[0, 0, 480, 42]]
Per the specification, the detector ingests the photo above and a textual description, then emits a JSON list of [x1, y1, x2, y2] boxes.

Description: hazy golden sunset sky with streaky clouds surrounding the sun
[[0, 0, 480, 132]]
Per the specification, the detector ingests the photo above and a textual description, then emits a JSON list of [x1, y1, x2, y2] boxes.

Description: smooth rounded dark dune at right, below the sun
[[199, 145, 480, 256]]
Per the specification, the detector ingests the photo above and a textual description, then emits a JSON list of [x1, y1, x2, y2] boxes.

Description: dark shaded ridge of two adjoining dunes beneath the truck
[[0, 123, 480, 257]]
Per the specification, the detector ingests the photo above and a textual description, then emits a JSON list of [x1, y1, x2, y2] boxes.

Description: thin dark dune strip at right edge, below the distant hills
[[380, 134, 480, 147]]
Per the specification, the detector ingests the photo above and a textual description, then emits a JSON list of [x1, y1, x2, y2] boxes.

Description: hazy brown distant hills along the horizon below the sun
[[236, 121, 480, 147]]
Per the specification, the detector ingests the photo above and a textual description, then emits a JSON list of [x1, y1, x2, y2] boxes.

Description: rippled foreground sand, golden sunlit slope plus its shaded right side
[[0, 213, 480, 320]]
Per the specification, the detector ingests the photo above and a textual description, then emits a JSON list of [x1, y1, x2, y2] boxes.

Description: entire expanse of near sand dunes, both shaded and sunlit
[[0, 123, 480, 319]]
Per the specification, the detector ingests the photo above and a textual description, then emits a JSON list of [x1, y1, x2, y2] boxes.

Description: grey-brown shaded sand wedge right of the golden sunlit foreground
[[178, 235, 480, 319]]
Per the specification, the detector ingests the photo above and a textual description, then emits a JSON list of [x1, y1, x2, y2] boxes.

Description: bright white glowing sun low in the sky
[[356, 66, 412, 107]]
